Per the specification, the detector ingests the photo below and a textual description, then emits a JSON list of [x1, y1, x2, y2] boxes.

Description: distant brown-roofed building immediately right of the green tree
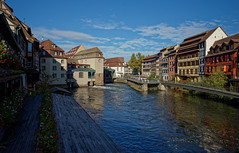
[[142, 54, 159, 77]]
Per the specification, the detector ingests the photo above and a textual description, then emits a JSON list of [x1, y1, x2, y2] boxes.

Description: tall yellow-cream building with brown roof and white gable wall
[[177, 27, 227, 81]]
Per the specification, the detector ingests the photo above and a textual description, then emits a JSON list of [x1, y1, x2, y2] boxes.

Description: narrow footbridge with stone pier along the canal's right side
[[127, 78, 239, 99]]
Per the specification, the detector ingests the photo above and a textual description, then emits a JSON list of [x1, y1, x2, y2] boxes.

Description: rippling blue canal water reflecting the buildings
[[73, 84, 239, 152]]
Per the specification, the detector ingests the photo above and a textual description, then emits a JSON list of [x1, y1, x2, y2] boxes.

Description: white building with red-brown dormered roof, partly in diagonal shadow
[[40, 40, 67, 85]]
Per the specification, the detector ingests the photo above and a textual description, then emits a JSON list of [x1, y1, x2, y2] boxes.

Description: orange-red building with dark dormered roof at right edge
[[206, 34, 239, 79]]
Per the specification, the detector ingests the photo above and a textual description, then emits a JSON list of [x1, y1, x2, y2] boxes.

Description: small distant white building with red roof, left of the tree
[[104, 57, 126, 78]]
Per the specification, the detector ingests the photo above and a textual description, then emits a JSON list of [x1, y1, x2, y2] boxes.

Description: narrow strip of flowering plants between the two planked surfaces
[[37, 88, 59, 153]]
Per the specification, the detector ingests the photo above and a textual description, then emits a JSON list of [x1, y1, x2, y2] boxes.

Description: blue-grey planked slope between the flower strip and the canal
[[52, 94, 122, 153]]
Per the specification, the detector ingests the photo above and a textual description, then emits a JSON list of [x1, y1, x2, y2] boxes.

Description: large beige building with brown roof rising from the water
[[67, 45, 104, 86]]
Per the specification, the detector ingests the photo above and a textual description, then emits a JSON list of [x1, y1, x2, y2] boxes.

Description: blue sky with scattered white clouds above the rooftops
[[5, 0, 239, 61]]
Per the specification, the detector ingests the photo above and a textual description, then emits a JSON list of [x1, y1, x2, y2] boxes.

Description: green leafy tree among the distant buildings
[[129, 53, 144, 72]]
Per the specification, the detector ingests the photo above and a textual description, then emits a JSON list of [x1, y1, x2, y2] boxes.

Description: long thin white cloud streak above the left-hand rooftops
[[33, 28, 110, 43]]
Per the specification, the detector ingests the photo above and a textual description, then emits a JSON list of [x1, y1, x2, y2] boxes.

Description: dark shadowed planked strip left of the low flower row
[[0, 95, 42, 153]]
